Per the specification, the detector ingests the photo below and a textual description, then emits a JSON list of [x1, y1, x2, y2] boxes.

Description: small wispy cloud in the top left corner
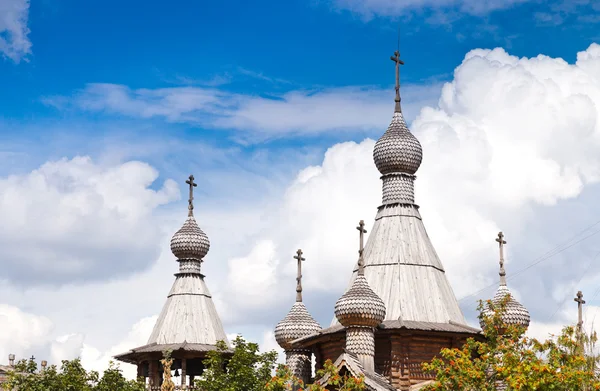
[[0, 0, 31, 63]]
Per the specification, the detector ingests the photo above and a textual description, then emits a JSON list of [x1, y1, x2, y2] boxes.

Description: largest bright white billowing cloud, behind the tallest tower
[[219, 45, 600, 330]]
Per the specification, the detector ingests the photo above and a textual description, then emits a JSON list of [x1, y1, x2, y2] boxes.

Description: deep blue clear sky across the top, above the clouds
[[0, 0, 597, 135]]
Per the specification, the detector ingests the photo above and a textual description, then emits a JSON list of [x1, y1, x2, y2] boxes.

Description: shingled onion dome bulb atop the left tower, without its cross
[[171, 214, 210, 260]]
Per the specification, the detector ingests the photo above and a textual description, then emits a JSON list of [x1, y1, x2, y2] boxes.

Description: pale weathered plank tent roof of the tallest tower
[[331, 204, 466, 325]]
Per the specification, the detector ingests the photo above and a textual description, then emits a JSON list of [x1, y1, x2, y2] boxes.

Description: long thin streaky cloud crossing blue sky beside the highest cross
[[44, 84, 441, 141]]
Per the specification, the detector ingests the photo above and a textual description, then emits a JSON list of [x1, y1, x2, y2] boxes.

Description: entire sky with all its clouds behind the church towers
[[0, 0, 600, 380]]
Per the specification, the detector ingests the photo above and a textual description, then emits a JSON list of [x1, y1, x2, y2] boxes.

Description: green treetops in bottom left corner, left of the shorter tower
[[4, 359, 145, 391]]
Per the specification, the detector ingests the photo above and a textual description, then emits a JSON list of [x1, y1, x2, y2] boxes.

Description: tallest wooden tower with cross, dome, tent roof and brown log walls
[[292, 51, 480, 390]]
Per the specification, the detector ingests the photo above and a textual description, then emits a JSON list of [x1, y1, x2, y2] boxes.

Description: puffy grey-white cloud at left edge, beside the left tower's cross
[[0, 157, 179, 286]]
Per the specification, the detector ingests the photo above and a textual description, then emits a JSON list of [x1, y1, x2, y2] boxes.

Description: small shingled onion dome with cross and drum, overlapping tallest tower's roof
[[335, 220, 385, 372]]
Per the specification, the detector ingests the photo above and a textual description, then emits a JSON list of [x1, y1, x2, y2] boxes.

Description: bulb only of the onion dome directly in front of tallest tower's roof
[[335, 274, 385, 327]]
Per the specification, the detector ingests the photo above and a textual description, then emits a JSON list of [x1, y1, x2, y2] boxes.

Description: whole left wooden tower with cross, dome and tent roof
[[115, 175, 229, 389]]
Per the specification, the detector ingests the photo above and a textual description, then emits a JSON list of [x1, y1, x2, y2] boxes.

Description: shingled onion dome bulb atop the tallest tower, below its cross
[[373, 112, 423, 175]]
